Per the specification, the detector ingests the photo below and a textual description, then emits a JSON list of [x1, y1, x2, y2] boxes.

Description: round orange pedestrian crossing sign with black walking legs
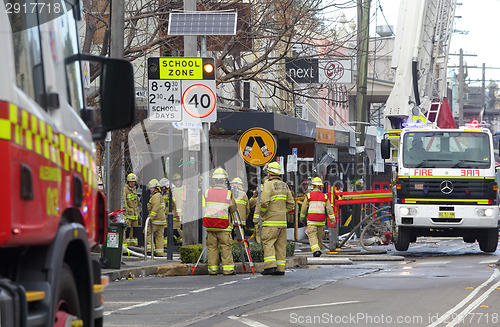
[[238, 127, 277, 166]]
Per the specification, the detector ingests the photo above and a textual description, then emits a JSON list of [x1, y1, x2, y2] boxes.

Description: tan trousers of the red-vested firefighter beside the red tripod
[[206, 231, 234, 275]]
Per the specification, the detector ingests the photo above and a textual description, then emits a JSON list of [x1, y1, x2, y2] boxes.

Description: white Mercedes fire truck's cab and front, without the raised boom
[[382, 123, 499, 252]]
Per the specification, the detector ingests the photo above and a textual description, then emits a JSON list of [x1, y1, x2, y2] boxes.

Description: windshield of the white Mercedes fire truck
[[403, 131, 491, 168]]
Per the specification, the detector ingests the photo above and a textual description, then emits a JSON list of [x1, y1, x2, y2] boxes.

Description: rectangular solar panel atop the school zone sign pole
[[168, 11, 238, 35]]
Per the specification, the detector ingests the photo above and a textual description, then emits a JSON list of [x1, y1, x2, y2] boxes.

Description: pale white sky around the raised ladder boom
[[345, 0, 500, 86]]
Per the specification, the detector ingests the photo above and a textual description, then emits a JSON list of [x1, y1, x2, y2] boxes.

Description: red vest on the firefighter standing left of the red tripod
[[203, 188, 232, 229]]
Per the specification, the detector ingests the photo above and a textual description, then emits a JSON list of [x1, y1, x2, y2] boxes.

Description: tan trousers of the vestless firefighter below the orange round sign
[[262, 226, 286, 272]]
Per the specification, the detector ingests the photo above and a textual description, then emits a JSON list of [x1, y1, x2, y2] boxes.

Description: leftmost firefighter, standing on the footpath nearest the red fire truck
[[123, 173, 139, 246]]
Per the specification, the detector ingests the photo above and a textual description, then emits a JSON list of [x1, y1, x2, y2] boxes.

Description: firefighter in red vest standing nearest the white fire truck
[[300, 177, 335, 257]]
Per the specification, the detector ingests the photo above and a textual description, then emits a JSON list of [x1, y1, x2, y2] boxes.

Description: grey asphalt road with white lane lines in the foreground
[[104, 238, 500, 327]]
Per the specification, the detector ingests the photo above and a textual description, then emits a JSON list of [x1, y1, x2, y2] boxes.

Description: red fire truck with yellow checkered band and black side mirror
[[0, 0, 135, 327]]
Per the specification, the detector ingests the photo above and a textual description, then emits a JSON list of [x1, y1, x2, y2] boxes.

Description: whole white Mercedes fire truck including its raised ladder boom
[[382, 0, 499, 252]]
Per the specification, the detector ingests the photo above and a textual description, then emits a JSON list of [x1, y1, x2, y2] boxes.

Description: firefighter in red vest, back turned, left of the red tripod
[[203, 168, 236, 276]]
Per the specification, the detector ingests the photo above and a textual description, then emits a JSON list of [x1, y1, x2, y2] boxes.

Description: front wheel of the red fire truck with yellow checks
[[54, 263, 83, 327]]
